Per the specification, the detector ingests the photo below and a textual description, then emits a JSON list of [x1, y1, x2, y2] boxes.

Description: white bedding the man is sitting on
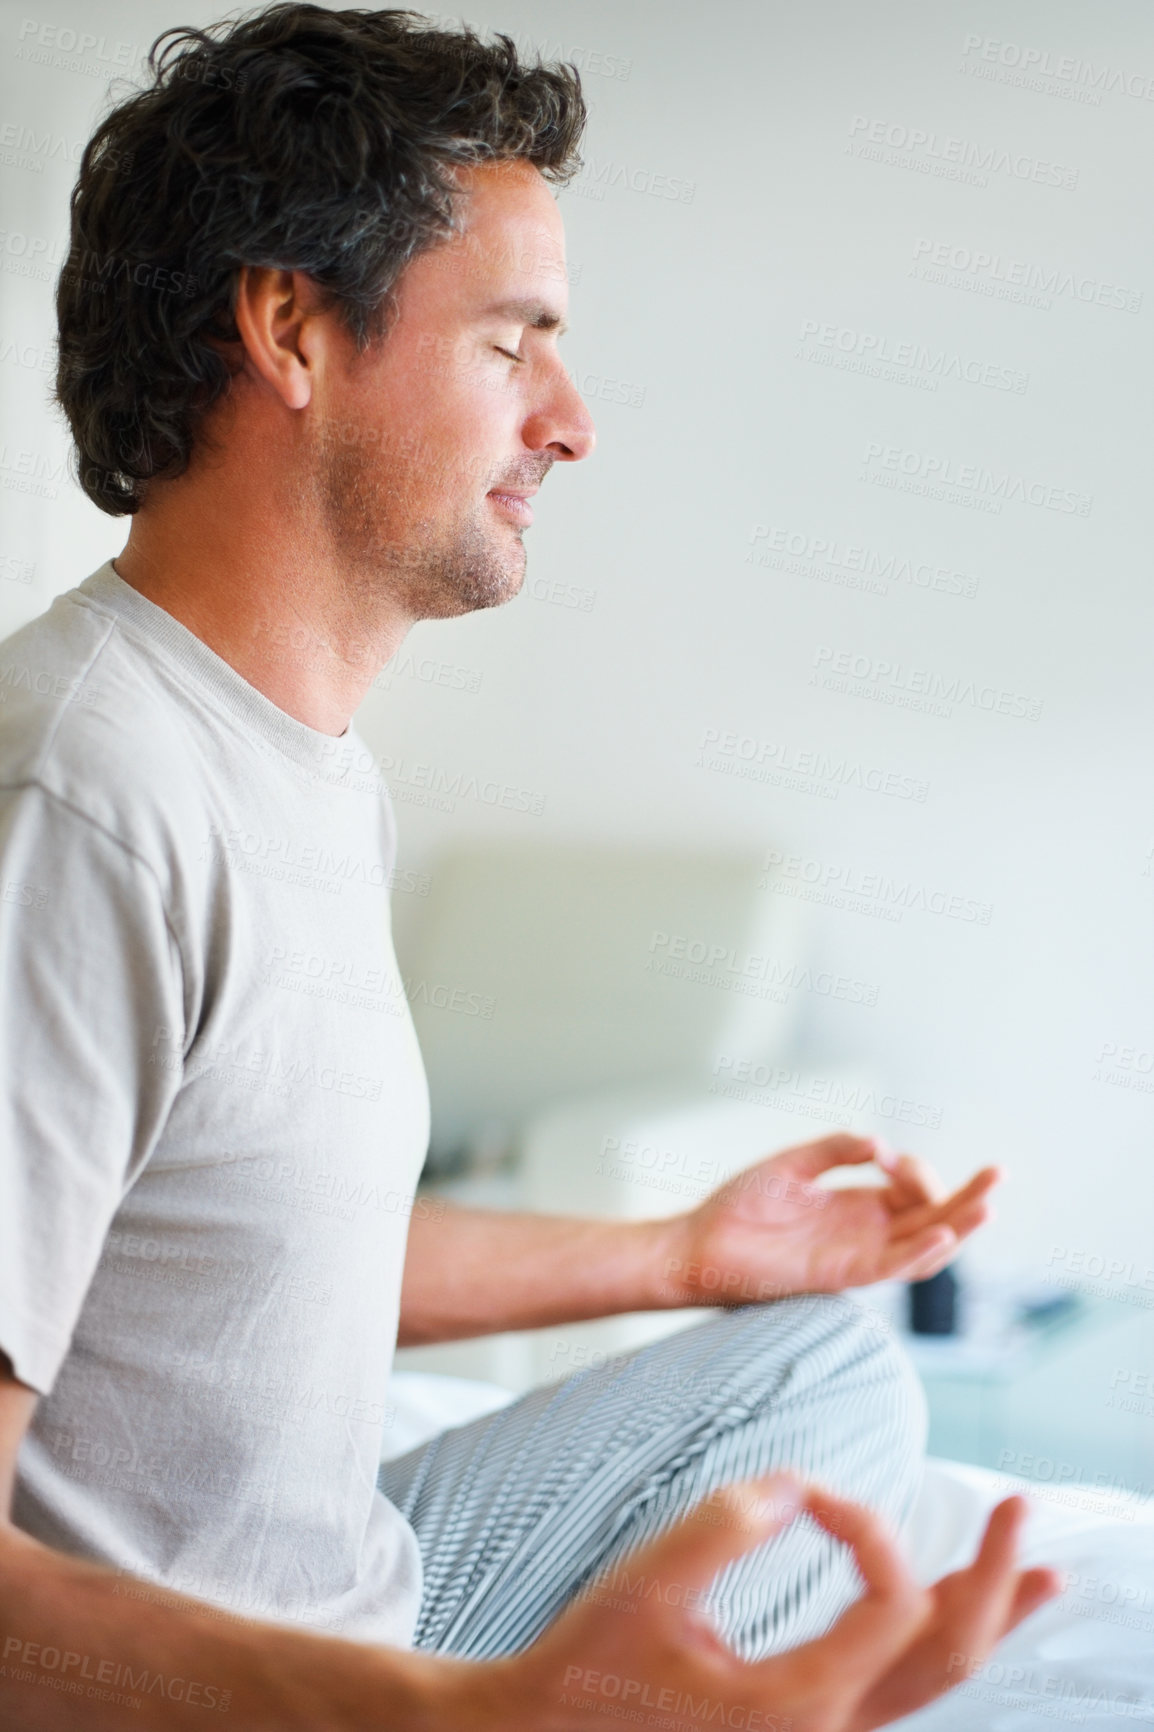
[[386, 1372, 1154, 1732]]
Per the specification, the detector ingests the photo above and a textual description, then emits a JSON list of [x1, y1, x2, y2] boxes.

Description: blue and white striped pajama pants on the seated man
[[379, 1294, 925, 1659]]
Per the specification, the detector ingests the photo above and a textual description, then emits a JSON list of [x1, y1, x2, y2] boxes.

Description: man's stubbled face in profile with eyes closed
[[298, 161, 594, 618]]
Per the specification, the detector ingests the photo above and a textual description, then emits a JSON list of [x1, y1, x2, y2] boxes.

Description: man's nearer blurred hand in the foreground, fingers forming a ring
[[478, 1474, 1062, 1732]]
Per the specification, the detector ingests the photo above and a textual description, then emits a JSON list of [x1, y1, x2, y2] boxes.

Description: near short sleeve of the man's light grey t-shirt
[[0, 785, 185, 1394]]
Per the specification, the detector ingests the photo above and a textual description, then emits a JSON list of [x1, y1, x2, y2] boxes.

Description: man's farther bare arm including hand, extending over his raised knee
[[397, 1133, 998, 1347]]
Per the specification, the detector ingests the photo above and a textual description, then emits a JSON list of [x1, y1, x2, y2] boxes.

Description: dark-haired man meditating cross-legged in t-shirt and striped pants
[[0, 3, 1057, 1732]]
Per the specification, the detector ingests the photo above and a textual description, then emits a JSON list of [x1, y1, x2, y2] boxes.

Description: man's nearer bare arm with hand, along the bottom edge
[[0, 1356, 1059, 1732]]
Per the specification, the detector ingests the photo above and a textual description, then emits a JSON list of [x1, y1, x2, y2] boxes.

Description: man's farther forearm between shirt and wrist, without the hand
[[397, 1207, 672, 1347]]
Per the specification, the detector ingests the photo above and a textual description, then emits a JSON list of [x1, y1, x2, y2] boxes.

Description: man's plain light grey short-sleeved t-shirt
[[0, 563, 428, 1647]]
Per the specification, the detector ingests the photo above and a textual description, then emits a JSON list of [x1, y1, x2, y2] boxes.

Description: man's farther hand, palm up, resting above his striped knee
[[657, 1133, 1002, 1304]]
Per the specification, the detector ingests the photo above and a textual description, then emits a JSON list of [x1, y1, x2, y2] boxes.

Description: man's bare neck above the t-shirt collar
[[114, 471, 412, 736]]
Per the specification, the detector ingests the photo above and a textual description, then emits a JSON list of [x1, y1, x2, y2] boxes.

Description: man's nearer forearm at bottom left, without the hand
[[0, 1526, 499, 1732]]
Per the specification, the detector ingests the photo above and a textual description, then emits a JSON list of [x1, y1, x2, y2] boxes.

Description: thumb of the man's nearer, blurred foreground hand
[[600, 1472, 806, 1611]]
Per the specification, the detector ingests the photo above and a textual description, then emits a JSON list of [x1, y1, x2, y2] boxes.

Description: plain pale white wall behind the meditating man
[[0, 0, 1154, 1287]]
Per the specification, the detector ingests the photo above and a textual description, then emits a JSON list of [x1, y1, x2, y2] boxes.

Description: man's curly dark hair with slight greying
[[55, 0, 586, 516]]
